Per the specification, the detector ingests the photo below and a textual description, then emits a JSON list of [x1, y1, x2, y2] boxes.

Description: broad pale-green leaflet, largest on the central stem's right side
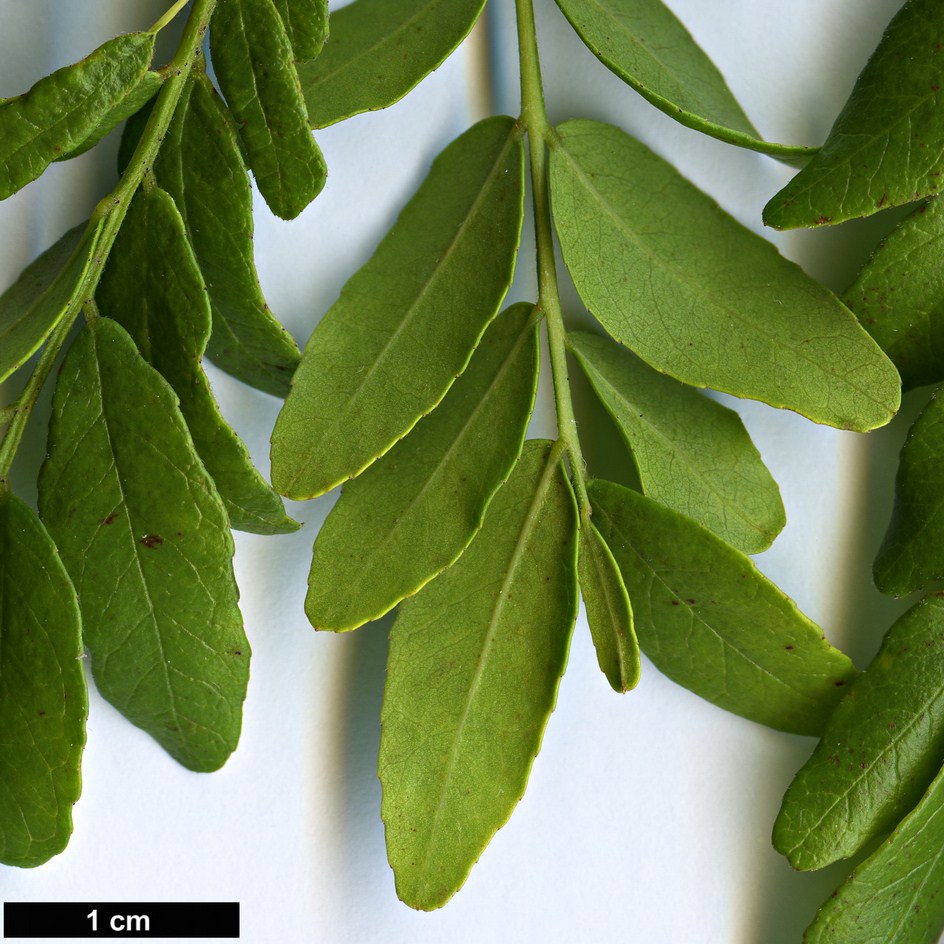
[[551, 121, 900, 430]]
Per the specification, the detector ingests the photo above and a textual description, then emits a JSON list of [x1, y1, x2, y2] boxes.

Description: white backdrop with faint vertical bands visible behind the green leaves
[[0, 0, 928, 944]]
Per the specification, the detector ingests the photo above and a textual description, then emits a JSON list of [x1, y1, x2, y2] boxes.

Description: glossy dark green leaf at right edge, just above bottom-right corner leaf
[[774, 596, 944, 869]]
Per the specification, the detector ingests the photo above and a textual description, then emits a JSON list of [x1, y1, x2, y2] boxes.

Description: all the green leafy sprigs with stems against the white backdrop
[[0, 0, 932, 944]]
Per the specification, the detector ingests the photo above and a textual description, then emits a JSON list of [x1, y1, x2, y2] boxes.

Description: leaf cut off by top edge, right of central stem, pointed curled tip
[[557, 0, 809, 154]]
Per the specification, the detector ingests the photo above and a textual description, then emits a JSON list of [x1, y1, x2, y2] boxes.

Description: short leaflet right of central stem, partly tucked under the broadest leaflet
[[569, 332, 786, 554]]
